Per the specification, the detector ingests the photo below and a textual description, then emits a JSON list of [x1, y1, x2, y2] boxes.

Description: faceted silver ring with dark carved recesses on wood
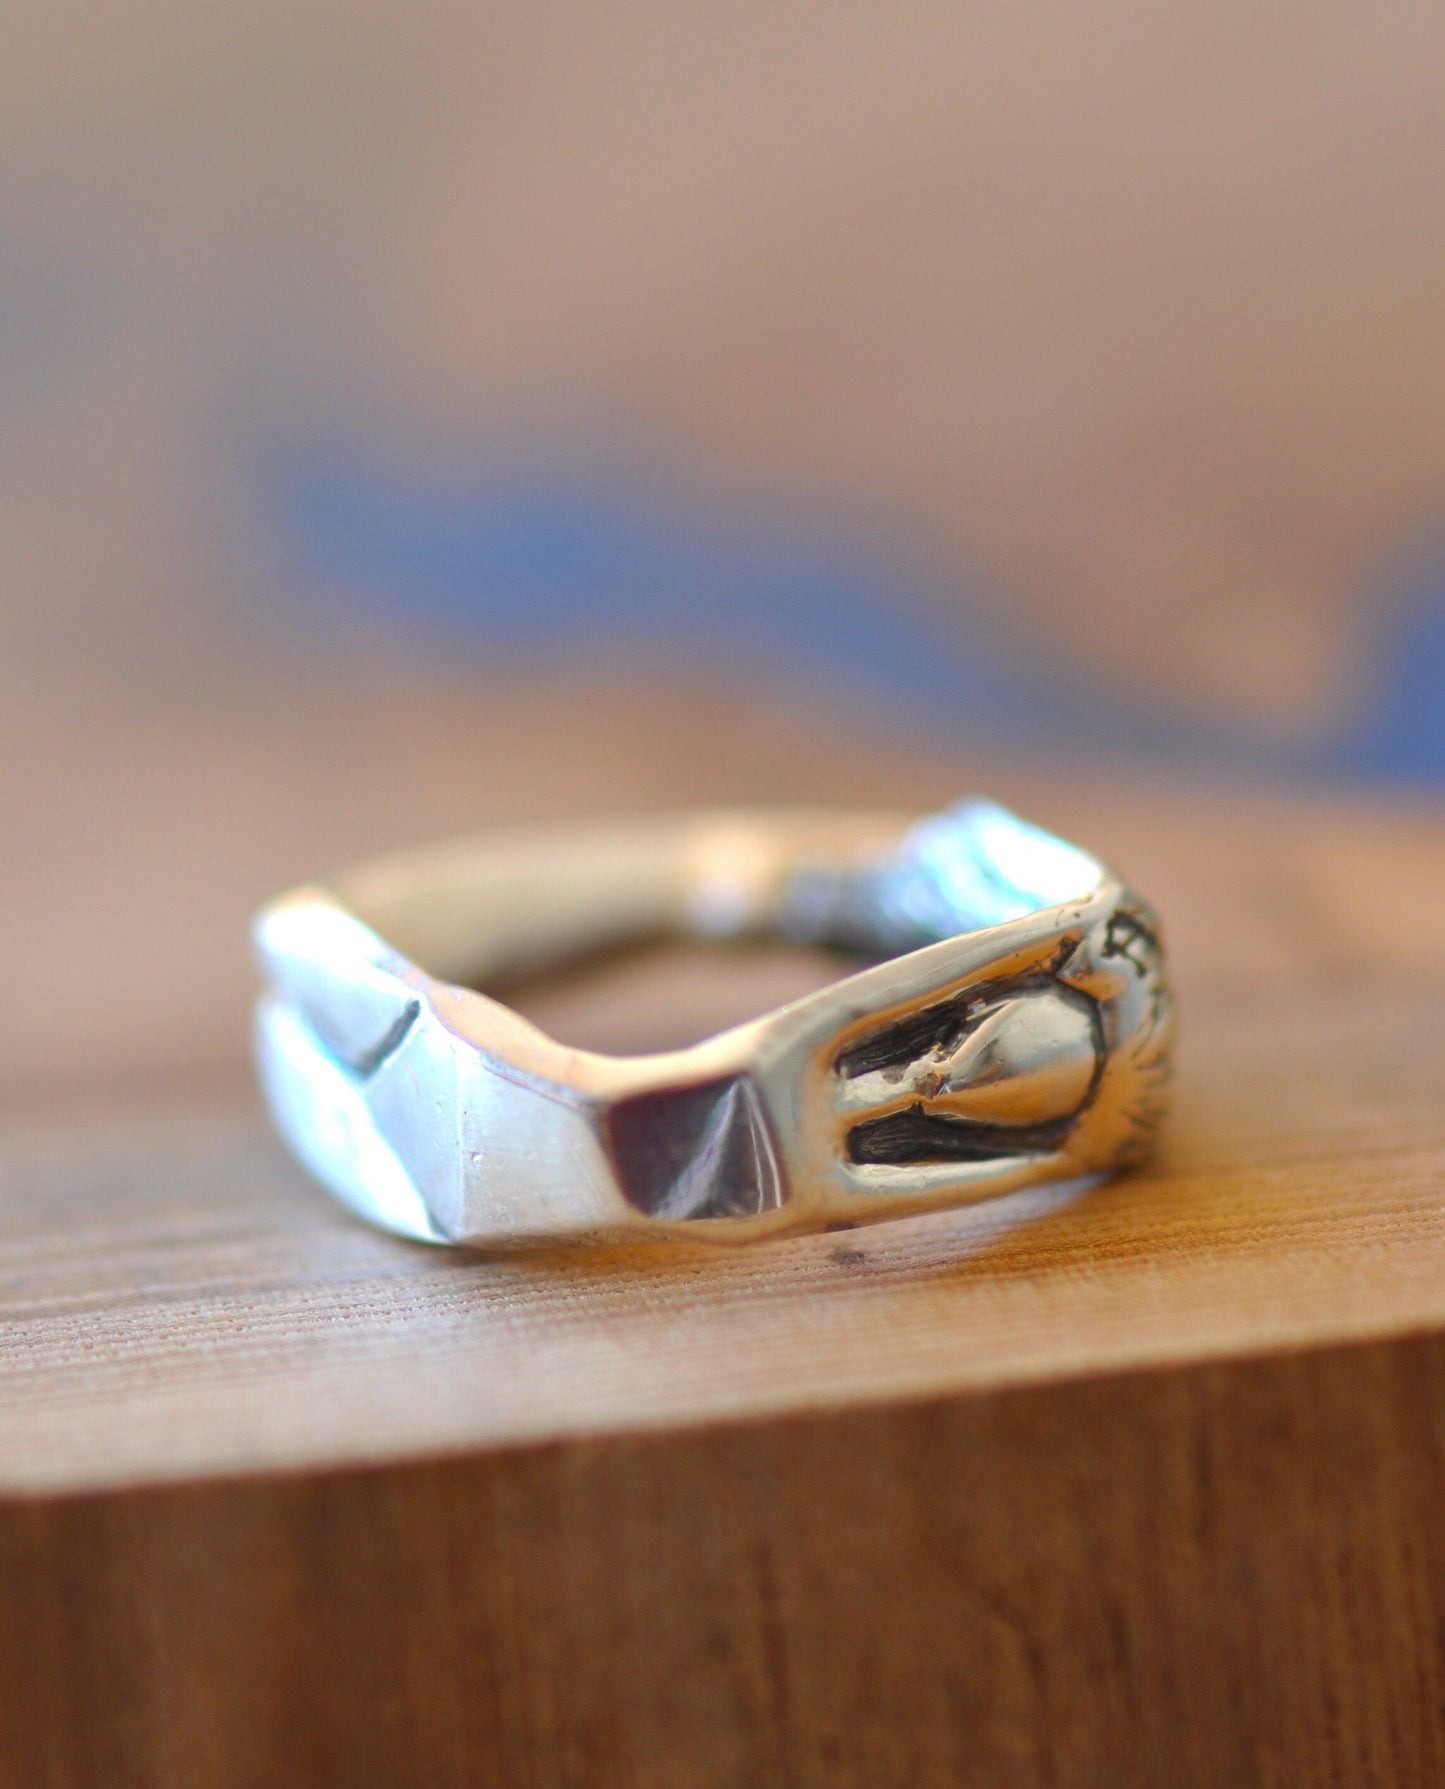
[[256, 801, 1173, 1247]]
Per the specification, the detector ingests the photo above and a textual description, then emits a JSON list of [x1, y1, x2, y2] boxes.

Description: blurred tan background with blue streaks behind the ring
[[0, 0, 1445, 1107]]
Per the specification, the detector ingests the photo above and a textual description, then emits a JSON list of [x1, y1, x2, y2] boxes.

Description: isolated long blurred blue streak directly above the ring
[[284, 465, 1073, 726]]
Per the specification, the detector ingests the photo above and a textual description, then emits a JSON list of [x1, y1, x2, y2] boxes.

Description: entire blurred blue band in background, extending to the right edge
[[272, 454, 1445, 784]]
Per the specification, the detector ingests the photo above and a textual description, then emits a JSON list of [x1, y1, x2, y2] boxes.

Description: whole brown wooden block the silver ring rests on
[[0, 701, 1445, 1789]]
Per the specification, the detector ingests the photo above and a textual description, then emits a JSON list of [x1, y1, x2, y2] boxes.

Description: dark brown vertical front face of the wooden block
[[0, 1336, 1445, 1789]]
